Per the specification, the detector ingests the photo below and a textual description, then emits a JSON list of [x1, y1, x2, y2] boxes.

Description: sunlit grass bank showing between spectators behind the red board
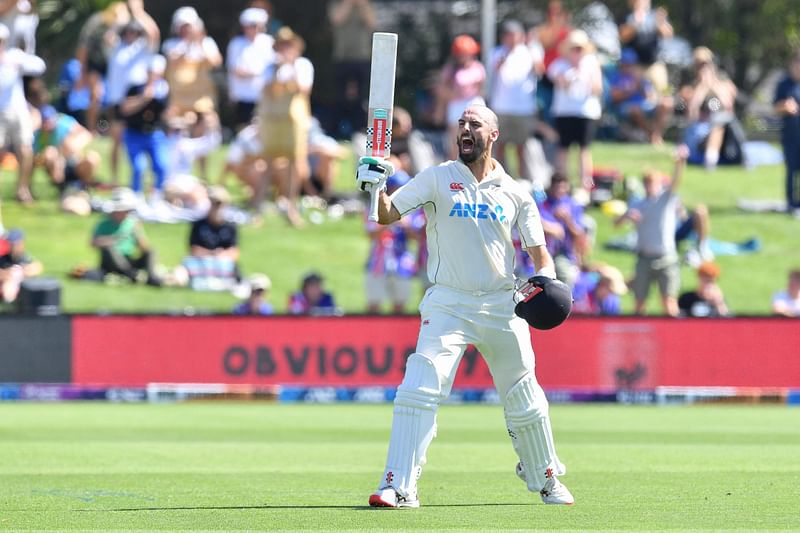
[[0, 140, 800, 315]]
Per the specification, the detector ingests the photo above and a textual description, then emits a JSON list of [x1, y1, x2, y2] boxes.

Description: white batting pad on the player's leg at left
[[380, 354, 443, 499]]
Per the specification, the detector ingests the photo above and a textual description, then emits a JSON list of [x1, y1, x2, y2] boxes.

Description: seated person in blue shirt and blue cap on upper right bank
[[610, 48, 672, 145]]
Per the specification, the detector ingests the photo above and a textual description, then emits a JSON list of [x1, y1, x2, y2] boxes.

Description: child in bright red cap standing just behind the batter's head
[[436, 35, 486, 159]]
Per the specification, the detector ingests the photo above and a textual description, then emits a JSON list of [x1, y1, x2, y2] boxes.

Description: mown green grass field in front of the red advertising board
[[0, 402, 800, 531]]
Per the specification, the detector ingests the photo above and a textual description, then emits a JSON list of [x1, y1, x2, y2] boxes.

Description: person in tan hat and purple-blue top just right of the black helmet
[[572, 264, 628, 316]]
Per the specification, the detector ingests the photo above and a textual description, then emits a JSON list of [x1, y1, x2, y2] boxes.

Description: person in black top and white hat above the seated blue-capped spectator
[[619, 0, 673, 96]]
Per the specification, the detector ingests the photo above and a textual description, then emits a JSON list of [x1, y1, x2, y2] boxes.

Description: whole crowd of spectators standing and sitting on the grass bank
[[0, 0, 800, 316]]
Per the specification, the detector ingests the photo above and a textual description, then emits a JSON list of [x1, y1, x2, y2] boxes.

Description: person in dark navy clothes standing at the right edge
[[773, 50, 800, 216]]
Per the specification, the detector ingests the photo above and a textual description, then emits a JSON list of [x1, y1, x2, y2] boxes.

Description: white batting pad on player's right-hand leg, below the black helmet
[[505, 376, 567, 492]]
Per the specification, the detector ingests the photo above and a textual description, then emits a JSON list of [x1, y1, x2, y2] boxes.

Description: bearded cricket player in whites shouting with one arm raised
[[356, 105, 574, 507]]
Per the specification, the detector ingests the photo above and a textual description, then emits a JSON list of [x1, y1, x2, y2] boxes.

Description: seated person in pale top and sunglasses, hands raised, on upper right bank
[[681, 46, 744, 170]]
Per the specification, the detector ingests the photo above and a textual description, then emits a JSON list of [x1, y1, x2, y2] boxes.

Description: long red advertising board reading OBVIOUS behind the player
[[72, 316, 800, 389]]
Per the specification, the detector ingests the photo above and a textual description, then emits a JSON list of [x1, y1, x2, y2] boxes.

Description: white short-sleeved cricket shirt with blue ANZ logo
[[390, 161, 545, 294]]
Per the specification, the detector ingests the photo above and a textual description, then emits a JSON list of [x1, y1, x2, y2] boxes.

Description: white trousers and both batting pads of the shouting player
[[379, 285, 565, 500]]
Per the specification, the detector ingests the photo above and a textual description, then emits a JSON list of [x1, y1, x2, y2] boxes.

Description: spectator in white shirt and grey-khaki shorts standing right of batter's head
[[490, 20, 544, 181]]
